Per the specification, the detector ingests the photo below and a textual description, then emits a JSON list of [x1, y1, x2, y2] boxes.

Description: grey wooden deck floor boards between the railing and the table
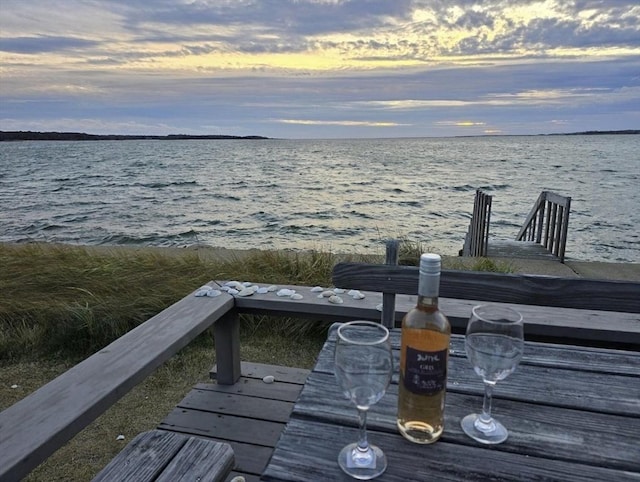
[[158, 362, 310, 482]]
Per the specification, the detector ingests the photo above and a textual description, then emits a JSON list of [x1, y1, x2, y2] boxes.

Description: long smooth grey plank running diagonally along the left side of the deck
[[0, 294, 234, 480]]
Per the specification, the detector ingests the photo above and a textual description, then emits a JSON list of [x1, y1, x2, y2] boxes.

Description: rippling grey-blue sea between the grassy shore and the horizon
[[0, 135, 640, 262]]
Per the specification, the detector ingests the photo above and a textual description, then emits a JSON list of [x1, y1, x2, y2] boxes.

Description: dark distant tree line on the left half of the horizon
[[0, 131, 268, 141]]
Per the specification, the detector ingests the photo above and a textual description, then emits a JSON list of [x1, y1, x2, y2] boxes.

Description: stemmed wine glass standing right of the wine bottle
[[461, 304, 524, 444]]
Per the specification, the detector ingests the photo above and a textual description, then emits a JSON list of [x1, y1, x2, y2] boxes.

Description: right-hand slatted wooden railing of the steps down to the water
[[516, 191, 571, 263]]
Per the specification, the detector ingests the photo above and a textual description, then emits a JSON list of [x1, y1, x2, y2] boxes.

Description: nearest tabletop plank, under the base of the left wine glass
[[263, 419, 638, 482]]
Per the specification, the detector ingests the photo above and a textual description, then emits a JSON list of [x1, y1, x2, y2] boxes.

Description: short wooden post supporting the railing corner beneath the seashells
[[213, 310, 241, 385]]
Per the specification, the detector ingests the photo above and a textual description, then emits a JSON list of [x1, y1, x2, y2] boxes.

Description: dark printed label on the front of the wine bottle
[[404, 346, 447, 395]]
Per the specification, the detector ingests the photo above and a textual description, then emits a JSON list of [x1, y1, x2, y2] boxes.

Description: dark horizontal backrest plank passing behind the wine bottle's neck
[[333, 263, 640, 313]]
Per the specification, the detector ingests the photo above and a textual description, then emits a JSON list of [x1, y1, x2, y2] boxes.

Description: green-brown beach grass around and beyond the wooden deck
[[0, 240, 512, 481]]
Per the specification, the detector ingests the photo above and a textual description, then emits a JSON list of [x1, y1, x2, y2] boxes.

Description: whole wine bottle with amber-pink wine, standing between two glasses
[[397, 253, 451, 444]]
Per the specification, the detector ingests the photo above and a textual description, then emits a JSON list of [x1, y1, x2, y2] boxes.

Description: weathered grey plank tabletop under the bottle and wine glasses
[[262, 326, 640, 482]]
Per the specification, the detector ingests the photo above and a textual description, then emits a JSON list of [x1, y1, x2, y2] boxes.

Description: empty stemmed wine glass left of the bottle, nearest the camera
[[335, 321, 393, 480]]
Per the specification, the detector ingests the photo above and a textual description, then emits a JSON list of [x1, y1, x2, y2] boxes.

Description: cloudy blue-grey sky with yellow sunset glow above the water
[[0, 0, 640, 139]]
